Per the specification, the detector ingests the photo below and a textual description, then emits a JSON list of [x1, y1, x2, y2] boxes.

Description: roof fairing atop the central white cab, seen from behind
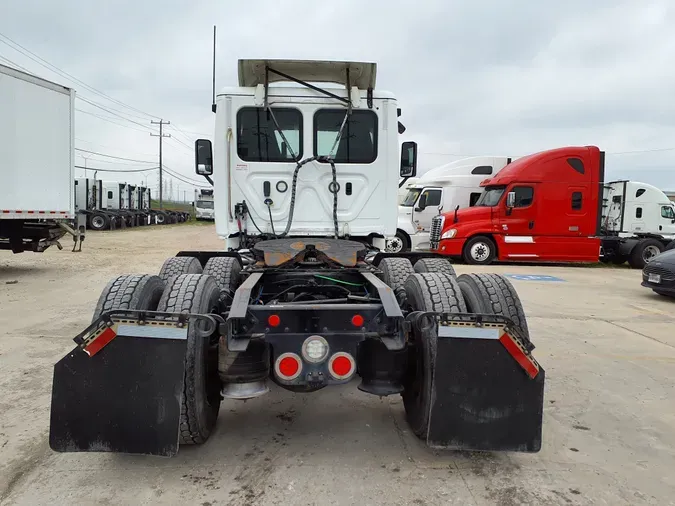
[[238, 60, 377, 90]]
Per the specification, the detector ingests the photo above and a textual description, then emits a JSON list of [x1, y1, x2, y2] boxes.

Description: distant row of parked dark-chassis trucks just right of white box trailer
[[74, 178, 190, 230]]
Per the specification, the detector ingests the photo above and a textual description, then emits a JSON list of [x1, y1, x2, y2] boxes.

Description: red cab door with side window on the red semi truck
[[498, 183, 541, 260]]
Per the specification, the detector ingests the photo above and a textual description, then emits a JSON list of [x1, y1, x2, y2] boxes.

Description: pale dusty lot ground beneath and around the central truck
[[0, 225, 675, 506]]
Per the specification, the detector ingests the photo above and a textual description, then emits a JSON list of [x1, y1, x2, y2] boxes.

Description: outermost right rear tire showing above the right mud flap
[[457, 274, 530, 342]]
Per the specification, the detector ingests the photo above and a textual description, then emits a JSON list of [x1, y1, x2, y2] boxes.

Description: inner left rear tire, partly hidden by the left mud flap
[[158, 274, 220, 444]]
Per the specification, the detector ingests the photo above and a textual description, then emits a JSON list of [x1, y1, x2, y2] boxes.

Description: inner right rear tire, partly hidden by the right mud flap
[[402, 272, 466, 439]]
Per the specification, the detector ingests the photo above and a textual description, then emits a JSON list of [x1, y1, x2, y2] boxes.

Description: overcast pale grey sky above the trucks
[[0, 0, 675, 200]]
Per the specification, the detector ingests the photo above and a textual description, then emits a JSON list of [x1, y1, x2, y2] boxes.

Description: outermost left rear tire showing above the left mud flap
[[92, 274, 164, 322]]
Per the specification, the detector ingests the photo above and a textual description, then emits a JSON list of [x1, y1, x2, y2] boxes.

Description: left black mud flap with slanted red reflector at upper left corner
[[49, 320, 187, 456]]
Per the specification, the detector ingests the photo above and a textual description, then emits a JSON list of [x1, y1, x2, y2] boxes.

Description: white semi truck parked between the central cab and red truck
[[387, 156, 516, 253]]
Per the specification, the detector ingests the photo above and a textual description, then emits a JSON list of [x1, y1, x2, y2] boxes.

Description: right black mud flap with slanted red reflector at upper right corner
[[427, 325, 545, 452]]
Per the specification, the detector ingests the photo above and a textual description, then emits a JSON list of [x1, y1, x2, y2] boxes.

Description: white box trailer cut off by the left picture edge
[[0, 65, 84, 253]]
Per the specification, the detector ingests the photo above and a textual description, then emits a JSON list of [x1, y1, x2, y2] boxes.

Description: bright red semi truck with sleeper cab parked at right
[[430, 146, 605, 264]]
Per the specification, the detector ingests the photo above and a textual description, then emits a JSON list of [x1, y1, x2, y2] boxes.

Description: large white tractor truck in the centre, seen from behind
[[49, 60, 545, 456]]
